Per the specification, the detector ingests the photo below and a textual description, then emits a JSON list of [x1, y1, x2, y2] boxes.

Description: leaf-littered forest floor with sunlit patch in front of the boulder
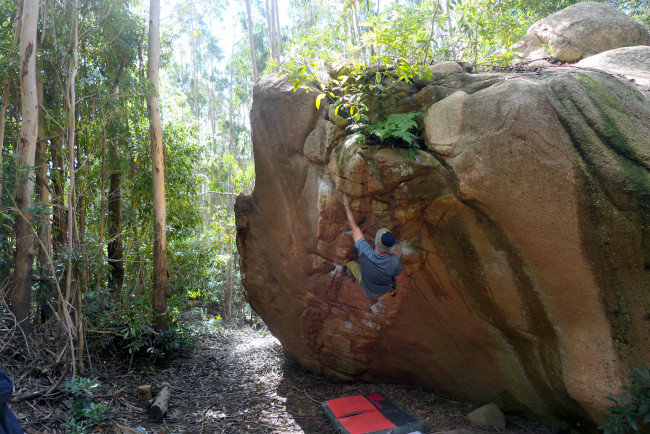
[[3, 316, 563, 434]]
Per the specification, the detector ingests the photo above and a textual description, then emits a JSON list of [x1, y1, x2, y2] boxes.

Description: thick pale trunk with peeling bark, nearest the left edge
[[10, 0, 38, 330]]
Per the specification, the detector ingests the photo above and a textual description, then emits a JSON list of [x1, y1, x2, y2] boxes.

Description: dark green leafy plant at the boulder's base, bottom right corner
[[598, 365, 650, 434]]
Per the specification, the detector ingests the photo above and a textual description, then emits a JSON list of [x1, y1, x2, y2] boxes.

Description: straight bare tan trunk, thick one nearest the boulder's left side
[[147, 0, 167, 330]]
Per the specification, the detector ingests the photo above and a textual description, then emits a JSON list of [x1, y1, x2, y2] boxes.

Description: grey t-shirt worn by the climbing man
[[354, 238, 402, 297]]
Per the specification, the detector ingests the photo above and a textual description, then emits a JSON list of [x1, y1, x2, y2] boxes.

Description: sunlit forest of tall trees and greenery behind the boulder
[[0, 0, 650, 388]]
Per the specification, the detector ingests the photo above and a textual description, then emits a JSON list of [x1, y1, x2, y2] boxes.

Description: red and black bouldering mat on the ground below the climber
[[322, 392, 424, 434]]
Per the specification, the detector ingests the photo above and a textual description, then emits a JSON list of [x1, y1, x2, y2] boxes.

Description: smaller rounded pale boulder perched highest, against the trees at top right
[[514, 2, 650, 63]]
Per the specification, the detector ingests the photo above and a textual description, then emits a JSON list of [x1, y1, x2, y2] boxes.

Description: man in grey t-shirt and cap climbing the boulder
[[343, 194, 403, 297]]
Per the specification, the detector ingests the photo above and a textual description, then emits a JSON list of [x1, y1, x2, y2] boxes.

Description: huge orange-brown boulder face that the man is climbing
[[235, 69, 650, 422]]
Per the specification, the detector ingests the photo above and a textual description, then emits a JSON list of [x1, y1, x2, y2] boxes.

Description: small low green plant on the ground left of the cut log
[[61, 377, 111, 434]]
